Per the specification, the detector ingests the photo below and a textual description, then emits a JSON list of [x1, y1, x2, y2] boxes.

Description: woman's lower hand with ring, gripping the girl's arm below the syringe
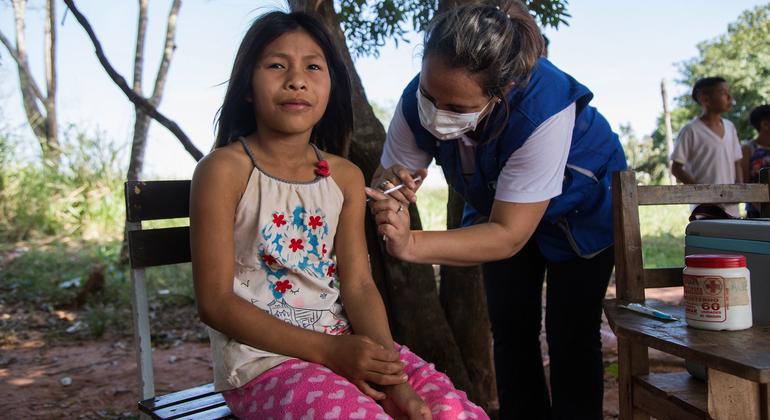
[[366, 188, 414, 261]]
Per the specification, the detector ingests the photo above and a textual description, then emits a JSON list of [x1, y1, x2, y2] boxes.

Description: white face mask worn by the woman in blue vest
[[417, 89, 494, 140]]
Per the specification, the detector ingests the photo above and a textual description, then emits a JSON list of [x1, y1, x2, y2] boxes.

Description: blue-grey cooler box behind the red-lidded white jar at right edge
[[684, 219, 770, 380]]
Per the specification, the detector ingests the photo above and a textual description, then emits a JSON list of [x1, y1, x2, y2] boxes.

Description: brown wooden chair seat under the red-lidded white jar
[[604, 299, 770, 384]]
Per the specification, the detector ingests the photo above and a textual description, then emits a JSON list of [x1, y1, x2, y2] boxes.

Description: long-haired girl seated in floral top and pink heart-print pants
[[190, 12, 486, 420]]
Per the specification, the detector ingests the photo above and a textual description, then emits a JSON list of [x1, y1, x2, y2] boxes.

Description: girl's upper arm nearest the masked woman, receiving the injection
[[334, 159, 371, 286]]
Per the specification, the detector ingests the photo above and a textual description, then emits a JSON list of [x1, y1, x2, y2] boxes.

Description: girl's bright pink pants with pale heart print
[[223, 346, 489, 420]]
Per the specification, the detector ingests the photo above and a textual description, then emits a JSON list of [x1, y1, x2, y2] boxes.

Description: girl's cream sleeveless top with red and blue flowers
[[209, 139, 350, 391]]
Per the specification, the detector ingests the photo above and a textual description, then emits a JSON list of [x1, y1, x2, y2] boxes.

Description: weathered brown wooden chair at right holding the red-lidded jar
[[604, 171, 770, 419]]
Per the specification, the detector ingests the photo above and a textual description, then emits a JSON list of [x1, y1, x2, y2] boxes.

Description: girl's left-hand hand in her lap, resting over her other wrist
[[323, 334, 407, 400]]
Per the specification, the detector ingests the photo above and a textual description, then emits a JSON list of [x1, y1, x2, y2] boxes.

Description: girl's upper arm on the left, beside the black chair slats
[[190, 151, 240, 311]]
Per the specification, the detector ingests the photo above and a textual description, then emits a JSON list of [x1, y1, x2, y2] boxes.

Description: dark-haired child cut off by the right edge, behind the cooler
[[743, 105, 770, 218]]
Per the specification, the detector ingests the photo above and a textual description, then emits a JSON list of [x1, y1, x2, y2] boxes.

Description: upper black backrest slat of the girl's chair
[[125, 180, 190, 222]]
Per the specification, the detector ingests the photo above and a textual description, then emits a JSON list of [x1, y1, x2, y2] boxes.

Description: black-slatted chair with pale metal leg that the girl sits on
[[125, 181, 233, 419]]
